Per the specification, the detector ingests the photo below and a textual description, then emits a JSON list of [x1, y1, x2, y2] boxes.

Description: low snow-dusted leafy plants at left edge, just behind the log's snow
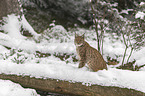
[[0, 46, 42, 64]]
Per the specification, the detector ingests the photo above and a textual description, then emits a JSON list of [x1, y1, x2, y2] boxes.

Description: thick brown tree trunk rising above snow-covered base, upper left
[[0, 0, 21, 20]]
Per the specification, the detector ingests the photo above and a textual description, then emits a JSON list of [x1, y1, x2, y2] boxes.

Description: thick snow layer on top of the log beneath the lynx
[[0, 57, 145, 92]]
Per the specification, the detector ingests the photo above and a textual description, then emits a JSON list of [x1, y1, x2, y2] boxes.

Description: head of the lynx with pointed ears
[[74, 33, 85, 46]]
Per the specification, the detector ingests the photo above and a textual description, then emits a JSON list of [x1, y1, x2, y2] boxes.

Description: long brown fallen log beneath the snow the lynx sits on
[[0, 74, 145, 96]]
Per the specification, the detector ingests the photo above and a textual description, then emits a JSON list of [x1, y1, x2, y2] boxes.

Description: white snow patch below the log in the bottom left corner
[[0, 80, 40, 96]]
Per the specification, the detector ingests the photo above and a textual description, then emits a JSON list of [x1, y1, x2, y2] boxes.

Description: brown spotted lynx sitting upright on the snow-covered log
[[74, 34, 107, 71]]
